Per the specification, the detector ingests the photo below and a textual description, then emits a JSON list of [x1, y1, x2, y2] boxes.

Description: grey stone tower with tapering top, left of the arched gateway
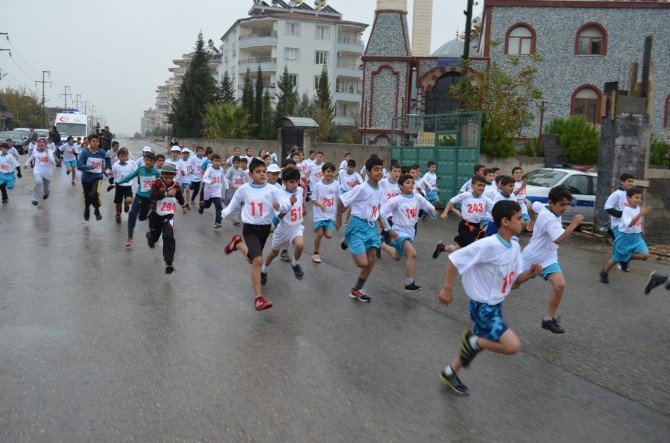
[[359, 0, 412, 145]]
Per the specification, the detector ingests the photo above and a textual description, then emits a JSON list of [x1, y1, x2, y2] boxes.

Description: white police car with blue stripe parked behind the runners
[[525, 167, 598, 225]]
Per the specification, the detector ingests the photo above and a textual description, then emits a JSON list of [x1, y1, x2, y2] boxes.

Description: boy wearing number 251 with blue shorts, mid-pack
[[312, 162, 340, 263]]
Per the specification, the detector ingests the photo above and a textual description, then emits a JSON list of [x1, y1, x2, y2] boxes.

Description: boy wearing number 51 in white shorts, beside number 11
[[261, 169, 305, 285]]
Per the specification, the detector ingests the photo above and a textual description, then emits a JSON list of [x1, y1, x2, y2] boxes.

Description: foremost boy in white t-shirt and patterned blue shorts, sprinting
[[439, 201, 542, 395]]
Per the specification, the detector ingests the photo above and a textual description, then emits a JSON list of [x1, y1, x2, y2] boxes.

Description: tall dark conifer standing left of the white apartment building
[[168, 33, 218, 137]]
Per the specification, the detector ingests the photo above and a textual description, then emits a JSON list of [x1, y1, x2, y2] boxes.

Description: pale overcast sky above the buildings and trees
[[0, 0, 482, 135]]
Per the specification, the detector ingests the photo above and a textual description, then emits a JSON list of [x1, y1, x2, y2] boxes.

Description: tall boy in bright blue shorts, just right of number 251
[[335, 156, 389, 303]]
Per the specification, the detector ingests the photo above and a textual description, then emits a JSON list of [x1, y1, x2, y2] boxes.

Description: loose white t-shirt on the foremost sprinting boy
[[449, 234, 530, 305]]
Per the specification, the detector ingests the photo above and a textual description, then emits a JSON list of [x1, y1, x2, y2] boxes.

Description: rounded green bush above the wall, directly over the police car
[[544, 115, 600, 165]]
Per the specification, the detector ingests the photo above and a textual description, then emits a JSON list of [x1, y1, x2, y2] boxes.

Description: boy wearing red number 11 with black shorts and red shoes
[[221, 160, 297, 311]]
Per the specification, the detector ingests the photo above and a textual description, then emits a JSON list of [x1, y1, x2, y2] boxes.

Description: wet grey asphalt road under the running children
[[0, 142, 670, 441]]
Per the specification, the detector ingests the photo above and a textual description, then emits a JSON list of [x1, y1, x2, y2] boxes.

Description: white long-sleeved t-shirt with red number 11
[[221, 183, 291, 225]]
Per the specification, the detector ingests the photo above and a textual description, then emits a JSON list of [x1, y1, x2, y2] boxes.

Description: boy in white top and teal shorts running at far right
[[600, 188, 651, 283]]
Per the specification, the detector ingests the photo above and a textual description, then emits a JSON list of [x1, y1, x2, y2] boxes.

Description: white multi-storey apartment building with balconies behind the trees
[[219, 0, 368, 125]]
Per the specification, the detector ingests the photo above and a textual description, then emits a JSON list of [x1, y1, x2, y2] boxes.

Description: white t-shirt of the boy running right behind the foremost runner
[[523, 206, 565, 268]]
